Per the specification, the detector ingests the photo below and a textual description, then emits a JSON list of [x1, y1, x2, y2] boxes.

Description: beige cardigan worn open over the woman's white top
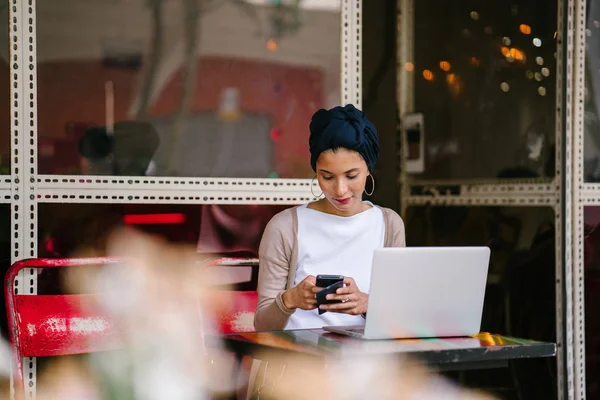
[[254, 207, 406, 331]]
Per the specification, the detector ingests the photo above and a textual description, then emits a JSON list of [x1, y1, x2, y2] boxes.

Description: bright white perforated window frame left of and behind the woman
[[7, 0, 362, 399]]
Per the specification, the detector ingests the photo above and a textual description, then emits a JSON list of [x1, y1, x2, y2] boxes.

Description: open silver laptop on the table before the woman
[[323, 247, 490, 339]]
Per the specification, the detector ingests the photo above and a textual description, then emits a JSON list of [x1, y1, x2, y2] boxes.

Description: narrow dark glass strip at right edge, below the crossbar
[[583, 206, 600, 399]]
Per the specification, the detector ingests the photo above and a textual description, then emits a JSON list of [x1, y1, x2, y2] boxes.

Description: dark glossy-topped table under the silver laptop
[[219, 329, 556, 371]]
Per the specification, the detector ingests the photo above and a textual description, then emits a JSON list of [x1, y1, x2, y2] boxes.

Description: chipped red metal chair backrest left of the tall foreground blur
[[4, 257, 122, 378]]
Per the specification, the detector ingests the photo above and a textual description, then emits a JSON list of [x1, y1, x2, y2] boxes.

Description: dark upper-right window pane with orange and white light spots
[[412, 0, 557, 179]]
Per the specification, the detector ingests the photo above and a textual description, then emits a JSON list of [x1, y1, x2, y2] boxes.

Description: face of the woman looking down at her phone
[[317, 148, 369, 216]]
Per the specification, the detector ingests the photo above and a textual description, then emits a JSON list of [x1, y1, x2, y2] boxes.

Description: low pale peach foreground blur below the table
[[252, 355, 494, 400]]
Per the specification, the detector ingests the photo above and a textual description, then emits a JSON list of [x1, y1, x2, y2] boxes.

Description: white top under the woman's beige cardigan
[[285, 202, 385, 329]]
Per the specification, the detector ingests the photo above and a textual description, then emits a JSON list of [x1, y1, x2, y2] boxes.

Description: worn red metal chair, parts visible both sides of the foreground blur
[[4, 257, 258, 398]]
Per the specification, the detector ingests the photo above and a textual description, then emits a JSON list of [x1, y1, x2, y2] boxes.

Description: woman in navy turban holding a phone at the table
[[254, 105, 405, 330]]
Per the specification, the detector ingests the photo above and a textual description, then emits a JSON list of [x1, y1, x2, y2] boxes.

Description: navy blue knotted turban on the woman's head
[[308, 104, 379, 171]]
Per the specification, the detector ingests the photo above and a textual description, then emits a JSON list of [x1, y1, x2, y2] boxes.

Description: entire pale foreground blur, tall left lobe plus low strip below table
[[0, 230, 490, 400]]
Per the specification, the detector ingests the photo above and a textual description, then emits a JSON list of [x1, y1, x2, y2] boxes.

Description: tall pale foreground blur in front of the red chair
[[70, 230, 239, 400]]
